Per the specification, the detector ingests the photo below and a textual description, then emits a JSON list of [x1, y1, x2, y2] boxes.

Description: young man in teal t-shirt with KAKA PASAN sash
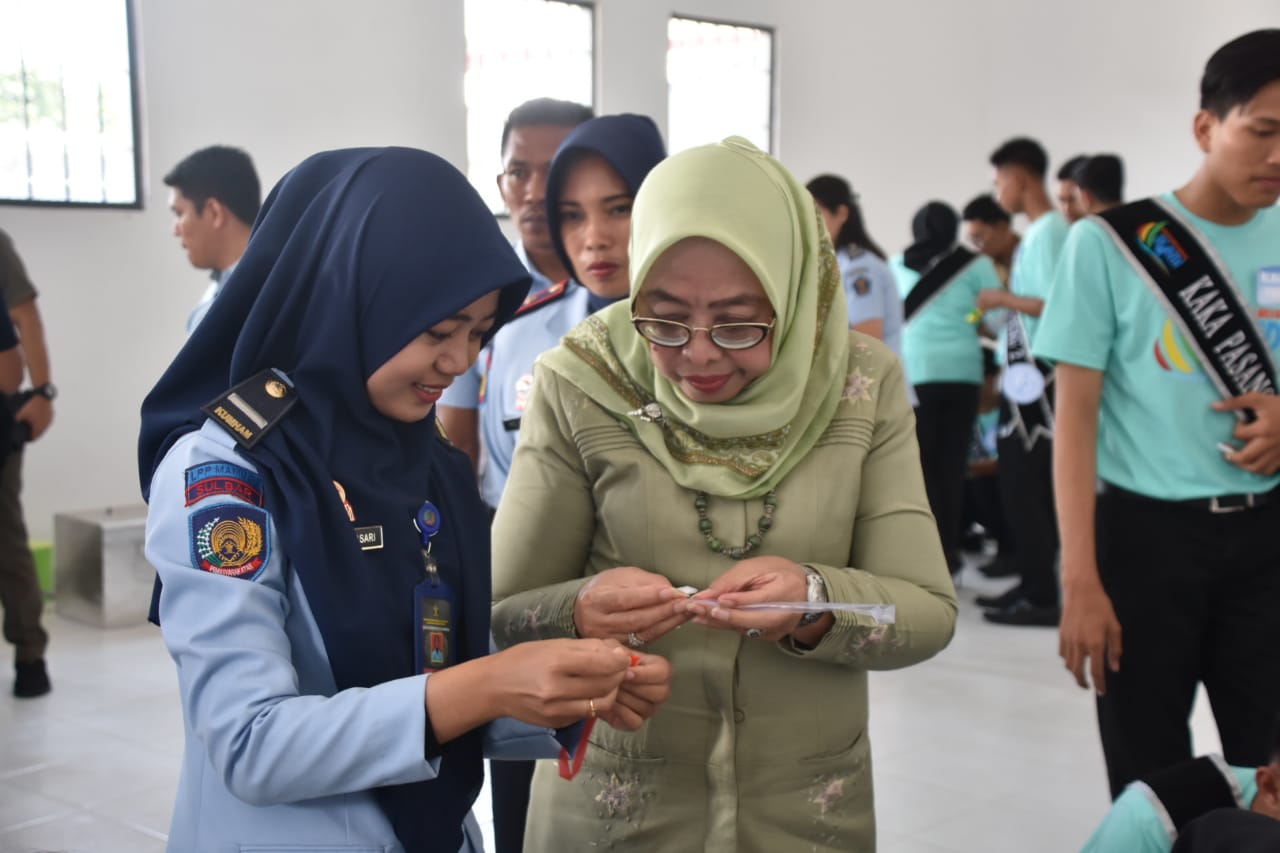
[[1034, 29, 1280, 795]]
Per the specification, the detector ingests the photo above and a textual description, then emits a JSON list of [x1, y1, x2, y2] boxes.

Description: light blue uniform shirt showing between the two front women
[[440, 242, 590, 507]]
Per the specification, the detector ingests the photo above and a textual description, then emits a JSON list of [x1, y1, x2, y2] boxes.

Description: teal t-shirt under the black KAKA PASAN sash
[[1033, 193, 1280, 501]]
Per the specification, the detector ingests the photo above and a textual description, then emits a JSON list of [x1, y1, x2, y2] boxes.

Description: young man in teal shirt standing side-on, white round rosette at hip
[[977, 137, 1066, 626]]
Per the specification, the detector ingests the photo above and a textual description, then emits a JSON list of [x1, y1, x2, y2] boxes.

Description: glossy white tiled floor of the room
[[0, 558, 1217, 853]]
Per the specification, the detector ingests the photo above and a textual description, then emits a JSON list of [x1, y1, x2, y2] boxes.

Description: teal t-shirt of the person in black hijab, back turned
[[888, 255, 1000, 386]]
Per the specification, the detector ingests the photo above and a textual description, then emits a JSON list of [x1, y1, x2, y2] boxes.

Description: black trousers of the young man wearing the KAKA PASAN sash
[[1097, 492, 1280, 797]]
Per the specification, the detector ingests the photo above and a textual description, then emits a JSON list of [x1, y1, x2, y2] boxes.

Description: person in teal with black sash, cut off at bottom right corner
[[1080, 727, 1280, 853]]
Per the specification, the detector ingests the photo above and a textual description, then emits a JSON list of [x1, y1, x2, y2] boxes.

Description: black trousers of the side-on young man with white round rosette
[[997, 414, 1059, 607]]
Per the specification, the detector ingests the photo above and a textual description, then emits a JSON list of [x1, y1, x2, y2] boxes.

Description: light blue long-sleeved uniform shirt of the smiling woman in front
[[146, 421, 576, 853]]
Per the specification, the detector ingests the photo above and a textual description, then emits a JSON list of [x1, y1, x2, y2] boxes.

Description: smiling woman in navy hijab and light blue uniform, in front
[[138, 149, 669, 853]]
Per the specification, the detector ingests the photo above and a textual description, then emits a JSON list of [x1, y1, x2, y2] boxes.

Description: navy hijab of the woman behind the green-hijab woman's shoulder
[[547, 113, 667, 289]]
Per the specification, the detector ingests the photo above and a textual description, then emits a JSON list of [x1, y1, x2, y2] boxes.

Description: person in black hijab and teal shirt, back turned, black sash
[[890, 201, 1000, 574]]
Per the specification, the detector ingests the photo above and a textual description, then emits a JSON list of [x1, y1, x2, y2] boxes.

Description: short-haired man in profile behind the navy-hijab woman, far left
[[164, 145, 262, 334]]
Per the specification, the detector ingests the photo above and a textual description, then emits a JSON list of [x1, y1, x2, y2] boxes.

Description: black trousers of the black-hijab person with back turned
[[915, 382, 979, 570]]
